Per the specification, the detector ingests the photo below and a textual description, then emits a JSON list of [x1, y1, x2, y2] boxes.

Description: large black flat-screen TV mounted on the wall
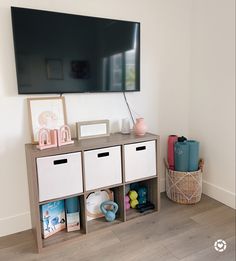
[[11, 7, 140, 94]]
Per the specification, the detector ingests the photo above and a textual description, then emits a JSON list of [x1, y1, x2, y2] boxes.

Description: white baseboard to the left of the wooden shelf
[[0, 212, 32, 237]]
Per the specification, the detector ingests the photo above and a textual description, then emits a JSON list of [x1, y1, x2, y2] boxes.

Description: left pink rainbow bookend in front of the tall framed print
[[37, 128, 57, 150]]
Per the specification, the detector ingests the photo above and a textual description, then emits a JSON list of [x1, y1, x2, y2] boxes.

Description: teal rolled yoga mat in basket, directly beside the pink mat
[[175, 141, 189, 171]]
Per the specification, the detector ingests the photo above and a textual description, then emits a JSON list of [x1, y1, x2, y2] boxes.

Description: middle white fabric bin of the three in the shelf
[[84, 146, 122, 190]]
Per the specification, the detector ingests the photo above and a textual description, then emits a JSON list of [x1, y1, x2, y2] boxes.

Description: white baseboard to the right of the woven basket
[[202, 180, 236, 209]]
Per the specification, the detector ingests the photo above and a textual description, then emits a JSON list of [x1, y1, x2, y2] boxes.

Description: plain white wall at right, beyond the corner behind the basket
[[189, 0, 235, 208]]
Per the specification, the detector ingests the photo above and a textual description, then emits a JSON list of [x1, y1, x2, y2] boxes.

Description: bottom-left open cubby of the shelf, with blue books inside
[[40, 195, 86, 247]]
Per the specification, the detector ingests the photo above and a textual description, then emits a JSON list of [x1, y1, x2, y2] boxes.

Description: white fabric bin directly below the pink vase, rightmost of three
[[125, 141, 156, 182]]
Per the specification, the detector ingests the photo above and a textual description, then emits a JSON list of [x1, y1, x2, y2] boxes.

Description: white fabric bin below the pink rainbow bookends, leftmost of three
[[37, 152, 83, 201]]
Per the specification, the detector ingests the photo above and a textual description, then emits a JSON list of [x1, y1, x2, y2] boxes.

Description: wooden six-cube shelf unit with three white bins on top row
[[25, 133, 160, 252]]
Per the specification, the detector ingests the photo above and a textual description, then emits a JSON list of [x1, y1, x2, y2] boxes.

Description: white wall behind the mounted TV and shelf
[[0, 0, 191, 236]]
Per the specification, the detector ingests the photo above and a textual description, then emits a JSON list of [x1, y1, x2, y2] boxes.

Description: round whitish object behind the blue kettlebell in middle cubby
[[86, 189, 114, 221]]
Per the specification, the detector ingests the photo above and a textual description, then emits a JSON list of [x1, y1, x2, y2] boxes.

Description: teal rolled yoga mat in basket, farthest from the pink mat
[[187, 140, 199, 171]]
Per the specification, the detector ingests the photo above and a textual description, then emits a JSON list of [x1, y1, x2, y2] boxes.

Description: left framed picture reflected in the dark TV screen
[[46, 59, 64, 80]]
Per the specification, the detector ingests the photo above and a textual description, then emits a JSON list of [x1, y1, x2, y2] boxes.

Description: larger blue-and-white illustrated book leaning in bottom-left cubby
[[40, 200, 66, 238]]
